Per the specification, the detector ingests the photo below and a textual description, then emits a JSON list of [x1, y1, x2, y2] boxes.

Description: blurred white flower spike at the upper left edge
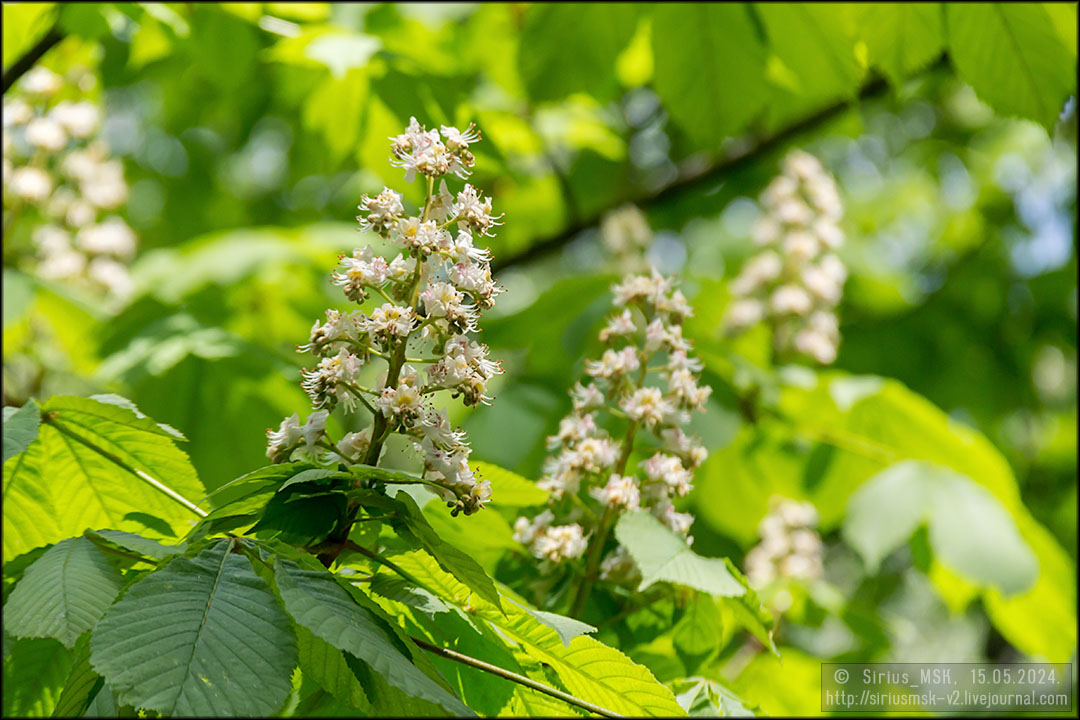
[[3, 66, 138, 301]]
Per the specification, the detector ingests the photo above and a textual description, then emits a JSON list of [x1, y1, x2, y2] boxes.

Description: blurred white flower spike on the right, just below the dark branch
[[726, 150, 848, 365]]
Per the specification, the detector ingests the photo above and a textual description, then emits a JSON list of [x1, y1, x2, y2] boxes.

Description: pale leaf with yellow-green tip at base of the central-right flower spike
[[615, 511, 775, 652]]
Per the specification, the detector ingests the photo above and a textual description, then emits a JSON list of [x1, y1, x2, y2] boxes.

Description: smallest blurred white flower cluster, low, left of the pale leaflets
[[746, 498, 823, 588]]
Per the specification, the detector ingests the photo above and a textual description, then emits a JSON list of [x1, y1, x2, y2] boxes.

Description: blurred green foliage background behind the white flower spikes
[[3, 3, 1077, 712]]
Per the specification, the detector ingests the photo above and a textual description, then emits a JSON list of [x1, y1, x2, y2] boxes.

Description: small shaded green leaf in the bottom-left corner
[[3, 638, 72, 718]]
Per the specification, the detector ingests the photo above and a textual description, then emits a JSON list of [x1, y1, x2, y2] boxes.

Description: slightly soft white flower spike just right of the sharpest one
[[514, 270, 712, 580]]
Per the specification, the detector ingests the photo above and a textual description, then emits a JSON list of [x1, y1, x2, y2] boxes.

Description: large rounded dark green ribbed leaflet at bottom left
[[91, 540, 297, 717]]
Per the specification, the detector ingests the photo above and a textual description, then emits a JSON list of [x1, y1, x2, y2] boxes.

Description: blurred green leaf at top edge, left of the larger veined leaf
[[517, 3, 637, 103]]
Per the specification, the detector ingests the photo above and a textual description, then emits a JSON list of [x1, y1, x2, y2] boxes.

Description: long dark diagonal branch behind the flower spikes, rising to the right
[[491, 55, 947, 270]]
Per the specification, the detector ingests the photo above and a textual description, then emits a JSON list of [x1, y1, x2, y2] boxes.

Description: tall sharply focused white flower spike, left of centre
[[267, 118, 503, 515]]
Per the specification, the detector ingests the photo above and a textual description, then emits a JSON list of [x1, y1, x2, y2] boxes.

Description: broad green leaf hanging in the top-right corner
[[945, 2, 1077, 130]]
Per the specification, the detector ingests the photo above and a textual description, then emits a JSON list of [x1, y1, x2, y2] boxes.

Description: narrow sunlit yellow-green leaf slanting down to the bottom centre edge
[[393, 552, 685, 717]]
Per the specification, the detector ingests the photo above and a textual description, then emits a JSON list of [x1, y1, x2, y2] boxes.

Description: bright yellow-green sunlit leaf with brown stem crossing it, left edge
[[3, 396, 205, 561]]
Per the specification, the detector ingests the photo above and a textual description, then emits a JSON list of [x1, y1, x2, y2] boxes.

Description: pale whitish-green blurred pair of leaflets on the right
[[843, 461, 1038, 595]]
